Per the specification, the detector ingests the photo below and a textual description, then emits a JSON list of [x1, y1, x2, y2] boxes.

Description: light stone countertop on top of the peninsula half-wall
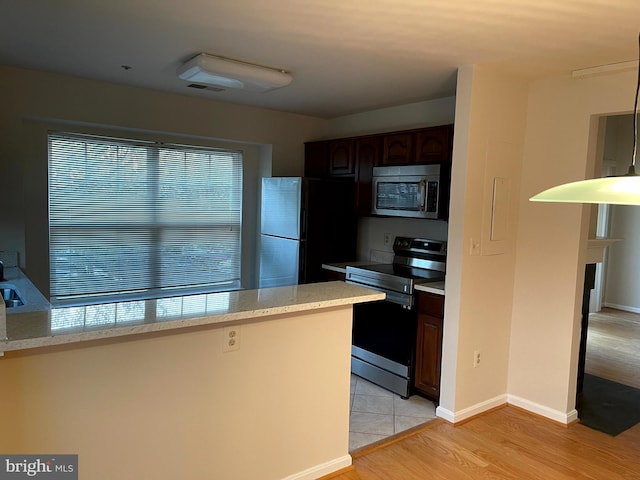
[[0, 282, 384, 352]]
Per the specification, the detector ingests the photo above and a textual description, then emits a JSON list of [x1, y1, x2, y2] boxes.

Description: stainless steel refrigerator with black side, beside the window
[[259, 177, 357, 288]]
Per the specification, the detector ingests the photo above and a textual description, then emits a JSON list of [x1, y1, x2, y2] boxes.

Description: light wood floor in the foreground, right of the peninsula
[[326, 406, 640, 480]]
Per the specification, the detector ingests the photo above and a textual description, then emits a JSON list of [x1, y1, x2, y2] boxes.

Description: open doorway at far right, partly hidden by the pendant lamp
[[576, 115, 640, 435]]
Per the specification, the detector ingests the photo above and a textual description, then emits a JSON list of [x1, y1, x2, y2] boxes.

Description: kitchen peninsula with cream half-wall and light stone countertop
[[0, 282, 384, 480]]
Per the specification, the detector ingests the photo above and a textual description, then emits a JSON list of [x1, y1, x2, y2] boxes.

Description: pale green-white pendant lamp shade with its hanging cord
[[529, 34, 640, 205]]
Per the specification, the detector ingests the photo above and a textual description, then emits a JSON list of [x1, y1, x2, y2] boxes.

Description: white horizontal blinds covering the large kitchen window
[[49, 134, 242, 303]]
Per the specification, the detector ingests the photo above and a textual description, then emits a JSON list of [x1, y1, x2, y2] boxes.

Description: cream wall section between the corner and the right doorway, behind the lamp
[[509, 67, 635, 421]]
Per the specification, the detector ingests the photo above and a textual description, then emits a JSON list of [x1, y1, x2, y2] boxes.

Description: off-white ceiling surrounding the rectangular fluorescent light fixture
[[0, 0, 640, 118]]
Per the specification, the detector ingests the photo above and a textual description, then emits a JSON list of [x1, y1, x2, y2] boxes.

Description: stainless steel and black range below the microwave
[[346, 237, 447, 398]]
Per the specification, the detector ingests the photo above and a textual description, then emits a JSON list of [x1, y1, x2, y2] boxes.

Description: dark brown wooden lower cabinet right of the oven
[[414, 292, 444, 403]]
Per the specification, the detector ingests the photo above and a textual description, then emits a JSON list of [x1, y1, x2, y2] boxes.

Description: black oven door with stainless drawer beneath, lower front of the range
[[351, 300, 417, 398]]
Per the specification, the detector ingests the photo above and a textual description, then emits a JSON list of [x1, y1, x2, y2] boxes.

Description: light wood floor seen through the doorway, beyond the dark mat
[[585, 308, 640, 388]]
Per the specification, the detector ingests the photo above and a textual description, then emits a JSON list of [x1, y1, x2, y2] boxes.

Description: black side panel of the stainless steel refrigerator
[[299, 178, 357, 283]]
